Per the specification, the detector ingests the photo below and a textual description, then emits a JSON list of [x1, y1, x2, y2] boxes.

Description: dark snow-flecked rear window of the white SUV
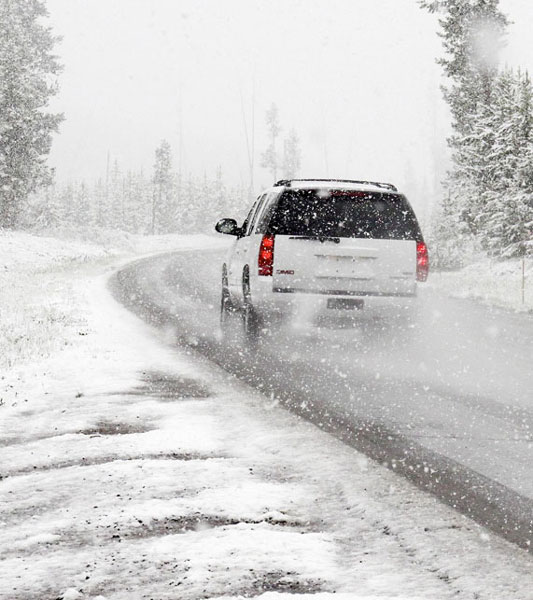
[[268, 190, 421, 240]]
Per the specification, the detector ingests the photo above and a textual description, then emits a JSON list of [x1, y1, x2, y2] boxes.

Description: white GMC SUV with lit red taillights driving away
[[216, 179, 429, 337]]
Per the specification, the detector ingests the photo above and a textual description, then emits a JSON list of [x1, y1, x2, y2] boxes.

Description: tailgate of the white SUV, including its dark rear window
[[268, 189, 421, 296]]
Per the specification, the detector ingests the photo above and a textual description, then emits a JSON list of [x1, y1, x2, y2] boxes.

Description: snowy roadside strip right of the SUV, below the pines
[[427, 258, 533, 312]]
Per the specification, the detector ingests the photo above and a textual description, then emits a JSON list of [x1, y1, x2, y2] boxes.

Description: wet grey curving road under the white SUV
[[115, 249, 533, 549]]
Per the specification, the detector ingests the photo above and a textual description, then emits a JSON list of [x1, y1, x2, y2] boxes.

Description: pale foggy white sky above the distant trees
[[47, 0, 533, 218]]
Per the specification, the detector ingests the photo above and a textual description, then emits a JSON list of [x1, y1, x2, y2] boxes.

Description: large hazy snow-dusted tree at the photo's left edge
[[0, 0, 63, 228]]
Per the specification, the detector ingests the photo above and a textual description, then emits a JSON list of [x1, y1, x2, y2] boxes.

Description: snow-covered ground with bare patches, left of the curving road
[[0, 234, 533, 600]]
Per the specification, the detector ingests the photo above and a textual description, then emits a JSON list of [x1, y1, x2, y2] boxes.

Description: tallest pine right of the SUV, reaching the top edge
[[420, 0, 508, 262]]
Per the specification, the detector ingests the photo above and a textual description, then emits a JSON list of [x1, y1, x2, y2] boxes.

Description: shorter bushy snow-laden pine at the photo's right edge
[[459, 69, 533, 256]]
